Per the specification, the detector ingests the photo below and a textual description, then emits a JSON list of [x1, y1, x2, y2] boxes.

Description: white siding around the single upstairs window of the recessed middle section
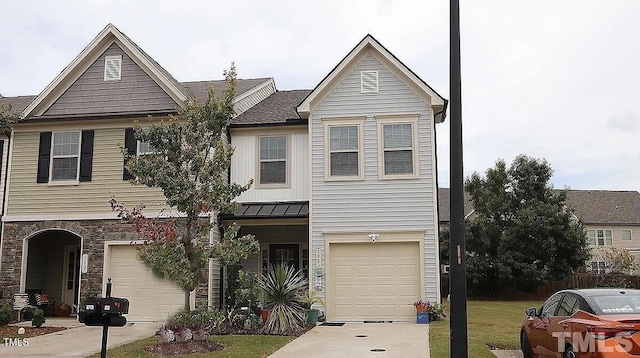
[[231, 126, 309, 202]]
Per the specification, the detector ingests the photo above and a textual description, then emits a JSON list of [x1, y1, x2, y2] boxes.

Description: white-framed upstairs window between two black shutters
[[51, 131, 80, 181]]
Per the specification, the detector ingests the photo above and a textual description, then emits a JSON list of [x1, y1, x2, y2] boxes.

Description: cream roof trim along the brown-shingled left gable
[[22, 24, 187, 118]]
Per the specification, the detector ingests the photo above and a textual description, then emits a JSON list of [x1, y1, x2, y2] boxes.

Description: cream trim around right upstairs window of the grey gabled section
[[376, 114, 420, 180]]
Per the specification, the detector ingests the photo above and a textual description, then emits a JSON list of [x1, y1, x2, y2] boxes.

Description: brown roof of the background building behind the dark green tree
[[438, 188, 640, 225]]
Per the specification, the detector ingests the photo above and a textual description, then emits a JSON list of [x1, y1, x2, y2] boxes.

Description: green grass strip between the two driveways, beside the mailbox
[[89, 335, 296, 358]]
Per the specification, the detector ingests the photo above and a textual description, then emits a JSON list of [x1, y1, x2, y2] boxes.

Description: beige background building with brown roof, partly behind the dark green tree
[[438, 188, 640, 271]]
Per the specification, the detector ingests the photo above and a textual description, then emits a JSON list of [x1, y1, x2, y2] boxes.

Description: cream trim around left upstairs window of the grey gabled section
[[322, 117, 365, 181]]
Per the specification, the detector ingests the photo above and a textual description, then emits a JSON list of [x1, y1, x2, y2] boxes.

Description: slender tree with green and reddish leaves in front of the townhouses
[[111, 65, 260, 310]]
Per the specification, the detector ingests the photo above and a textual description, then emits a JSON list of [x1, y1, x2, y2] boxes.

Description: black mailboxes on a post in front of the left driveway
[[78, 278, 129, 358]]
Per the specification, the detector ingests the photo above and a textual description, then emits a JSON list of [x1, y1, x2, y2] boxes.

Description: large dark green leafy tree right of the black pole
[[465, 155, 590, 292]]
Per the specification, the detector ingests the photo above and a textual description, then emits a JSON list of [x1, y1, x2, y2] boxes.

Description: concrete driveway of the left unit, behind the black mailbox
[[0, 318, 158, 358]]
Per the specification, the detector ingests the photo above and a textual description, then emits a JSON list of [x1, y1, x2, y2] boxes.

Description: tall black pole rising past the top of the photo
[[449, 0, 468, 358]]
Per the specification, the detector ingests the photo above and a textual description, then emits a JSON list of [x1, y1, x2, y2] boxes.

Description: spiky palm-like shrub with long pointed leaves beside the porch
[[260, 265, 309, 335]]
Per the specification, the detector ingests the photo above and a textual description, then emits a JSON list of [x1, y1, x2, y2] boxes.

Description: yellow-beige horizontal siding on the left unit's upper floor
[[6, 121, 164, 219]]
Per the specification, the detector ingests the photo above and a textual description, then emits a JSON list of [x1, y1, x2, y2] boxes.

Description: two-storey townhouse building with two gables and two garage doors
[[0, 25, 447, 321]]
